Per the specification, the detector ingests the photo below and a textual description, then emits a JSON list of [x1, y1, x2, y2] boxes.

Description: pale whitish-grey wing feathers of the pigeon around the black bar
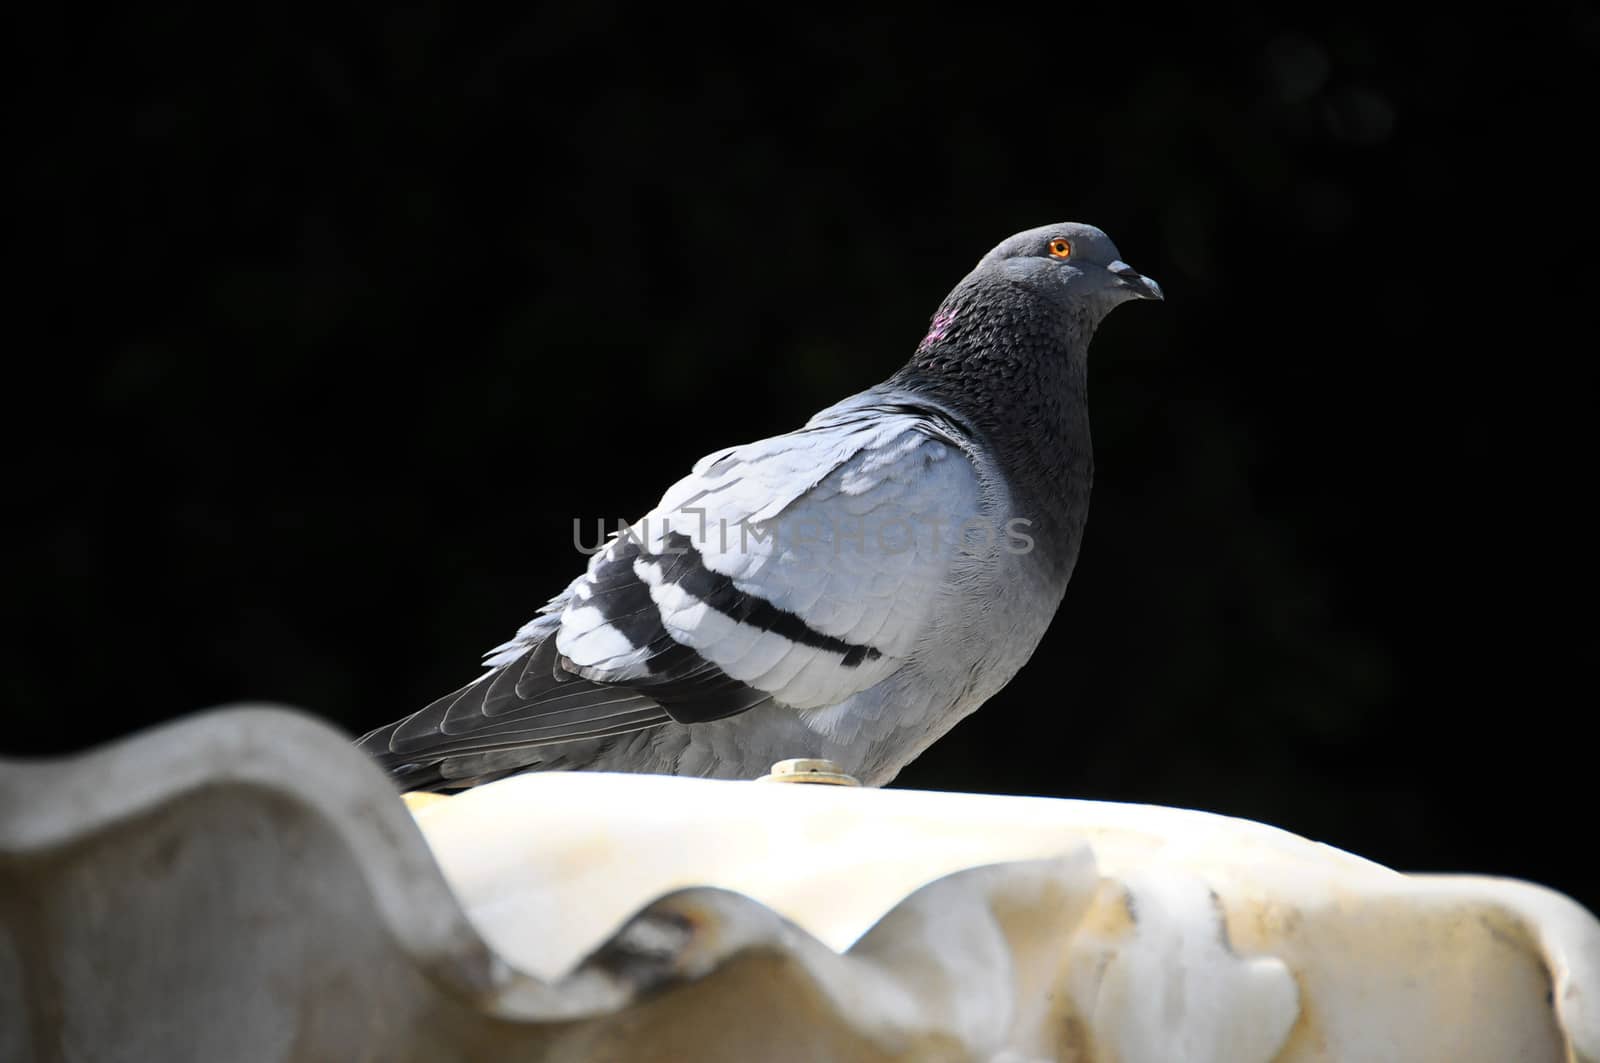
[[556, 405, 982, 708]]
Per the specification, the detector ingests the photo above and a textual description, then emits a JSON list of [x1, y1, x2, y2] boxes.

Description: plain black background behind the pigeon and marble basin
[[0, 3, 1600, 908]]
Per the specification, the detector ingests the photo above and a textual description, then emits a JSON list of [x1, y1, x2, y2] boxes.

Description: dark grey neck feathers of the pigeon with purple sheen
[[888, 275, 1101, 589]]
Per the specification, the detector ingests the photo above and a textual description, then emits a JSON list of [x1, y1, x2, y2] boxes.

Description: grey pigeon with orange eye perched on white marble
[[358, 223, 1162, 791]]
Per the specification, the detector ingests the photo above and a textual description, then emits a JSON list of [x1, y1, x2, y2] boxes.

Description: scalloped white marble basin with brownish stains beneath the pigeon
[[0, 709, 1600, 1063]]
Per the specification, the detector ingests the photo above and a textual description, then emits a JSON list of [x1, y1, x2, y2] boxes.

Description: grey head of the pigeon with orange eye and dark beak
[[974, 221, 1162, 315]]
